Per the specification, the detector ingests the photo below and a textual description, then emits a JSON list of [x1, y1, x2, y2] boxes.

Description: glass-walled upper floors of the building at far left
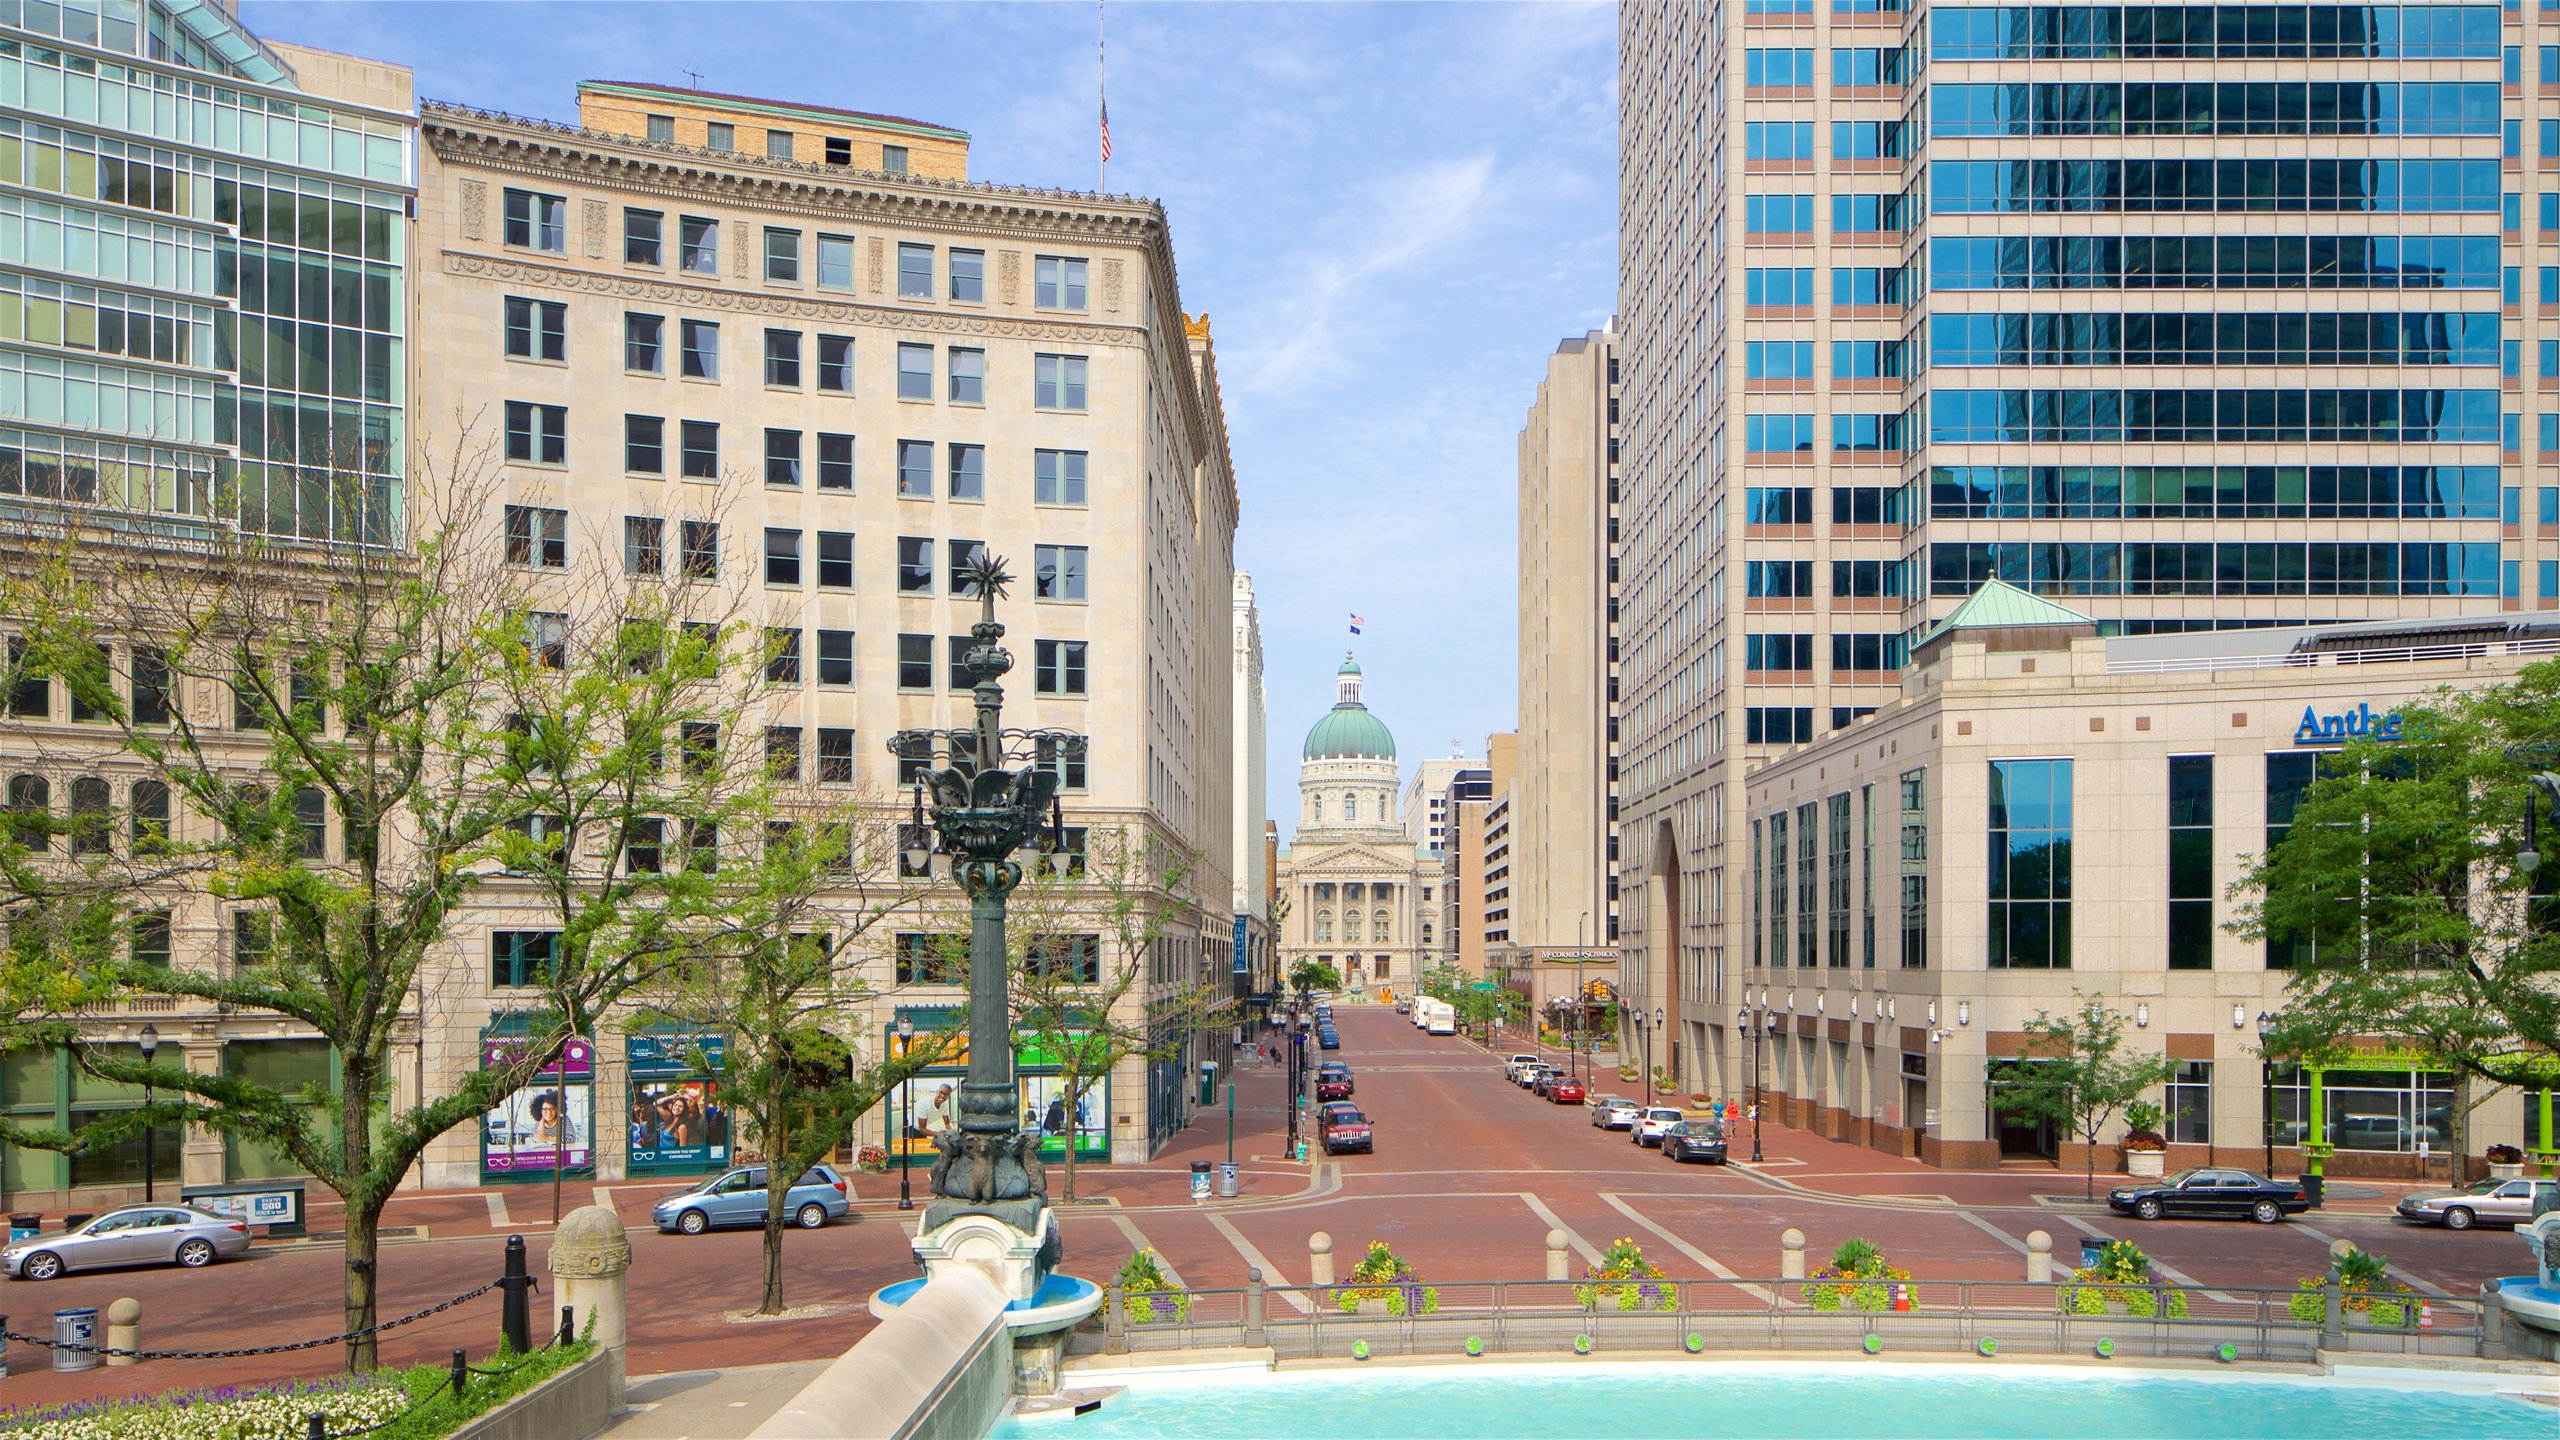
[[0, 0, 417, 543]]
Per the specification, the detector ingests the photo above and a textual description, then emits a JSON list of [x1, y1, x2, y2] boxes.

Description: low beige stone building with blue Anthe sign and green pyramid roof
[[1740, 587, 2560, 1179]]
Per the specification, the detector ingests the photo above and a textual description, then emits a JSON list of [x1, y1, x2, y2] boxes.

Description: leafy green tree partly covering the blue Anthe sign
[[2230, 661, 2560, 1096]]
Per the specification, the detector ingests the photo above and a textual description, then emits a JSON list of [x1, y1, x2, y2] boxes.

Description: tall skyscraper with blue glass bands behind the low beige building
[[1618, 0, 2519, 1112]]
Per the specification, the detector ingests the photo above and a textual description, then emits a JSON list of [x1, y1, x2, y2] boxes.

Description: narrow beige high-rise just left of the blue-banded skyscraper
[[1508, 331, 1618, 948]]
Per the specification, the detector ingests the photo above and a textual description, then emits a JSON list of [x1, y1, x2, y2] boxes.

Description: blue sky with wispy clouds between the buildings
[[259, 0, 1618, 830]]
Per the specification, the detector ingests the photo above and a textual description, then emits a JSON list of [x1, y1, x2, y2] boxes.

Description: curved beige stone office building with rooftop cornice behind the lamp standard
[[412, 82, 1239, 1184]]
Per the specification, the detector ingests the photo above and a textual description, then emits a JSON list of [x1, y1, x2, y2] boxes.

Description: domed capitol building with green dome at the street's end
[[1280, 653, 1446, 999]]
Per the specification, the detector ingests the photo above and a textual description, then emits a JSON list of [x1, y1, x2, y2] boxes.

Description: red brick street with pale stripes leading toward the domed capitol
[[0, 1007, 2524, 1407]]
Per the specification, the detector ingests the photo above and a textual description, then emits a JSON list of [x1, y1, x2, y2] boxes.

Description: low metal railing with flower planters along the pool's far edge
[[1070, 1279, 2504, 1363]]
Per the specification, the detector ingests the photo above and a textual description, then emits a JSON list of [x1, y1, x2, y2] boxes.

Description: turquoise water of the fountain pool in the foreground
[[996, 1361, 2560, 1440]]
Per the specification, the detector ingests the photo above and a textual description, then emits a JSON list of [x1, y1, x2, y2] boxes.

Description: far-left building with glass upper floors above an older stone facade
[[0, 0, 417, 1209]]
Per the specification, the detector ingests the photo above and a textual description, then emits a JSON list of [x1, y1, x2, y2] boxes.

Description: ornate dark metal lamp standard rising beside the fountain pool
[[888, 551, 1083, 1255]]
